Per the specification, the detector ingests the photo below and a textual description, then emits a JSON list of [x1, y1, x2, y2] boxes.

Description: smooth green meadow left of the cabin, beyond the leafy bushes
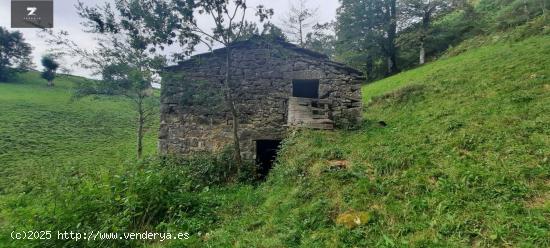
[[0, 72, 160, 247]]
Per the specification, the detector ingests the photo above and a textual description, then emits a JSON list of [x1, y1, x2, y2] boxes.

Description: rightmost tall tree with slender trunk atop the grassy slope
[[400, 0, 455, 65]]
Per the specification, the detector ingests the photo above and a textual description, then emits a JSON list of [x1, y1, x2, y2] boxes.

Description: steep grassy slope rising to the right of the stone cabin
[[203, 36, 550, 247]]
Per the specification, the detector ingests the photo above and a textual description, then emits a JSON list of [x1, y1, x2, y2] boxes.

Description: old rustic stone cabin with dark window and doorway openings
[[159, 37, 365, 172]]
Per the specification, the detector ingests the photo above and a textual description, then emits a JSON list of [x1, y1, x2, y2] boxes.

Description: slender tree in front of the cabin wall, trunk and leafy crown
[[102, 0, 273, 172]]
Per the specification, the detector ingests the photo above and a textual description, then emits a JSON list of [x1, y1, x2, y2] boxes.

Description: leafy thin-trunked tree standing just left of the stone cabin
[[45, 0, 196, 158]]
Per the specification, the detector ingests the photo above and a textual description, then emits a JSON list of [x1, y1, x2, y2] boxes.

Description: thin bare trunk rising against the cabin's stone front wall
[[224, 47, 242, 172]]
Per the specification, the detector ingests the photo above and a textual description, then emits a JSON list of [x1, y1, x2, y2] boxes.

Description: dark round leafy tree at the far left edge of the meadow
[[0, 27, 32, 81]]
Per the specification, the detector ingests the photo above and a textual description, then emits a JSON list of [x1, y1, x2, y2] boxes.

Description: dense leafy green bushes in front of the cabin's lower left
[[5, 149, 251, 247]]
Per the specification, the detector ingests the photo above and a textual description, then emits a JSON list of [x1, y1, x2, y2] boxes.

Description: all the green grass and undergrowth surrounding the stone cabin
[[0, 32, 550, 247]]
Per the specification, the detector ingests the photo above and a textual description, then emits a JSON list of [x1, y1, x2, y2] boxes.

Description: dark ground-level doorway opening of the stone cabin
[[256, 140, 281, 179]]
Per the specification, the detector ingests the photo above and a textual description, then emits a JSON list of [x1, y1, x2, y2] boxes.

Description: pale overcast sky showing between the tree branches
[[0, 0, 339, 77]]
